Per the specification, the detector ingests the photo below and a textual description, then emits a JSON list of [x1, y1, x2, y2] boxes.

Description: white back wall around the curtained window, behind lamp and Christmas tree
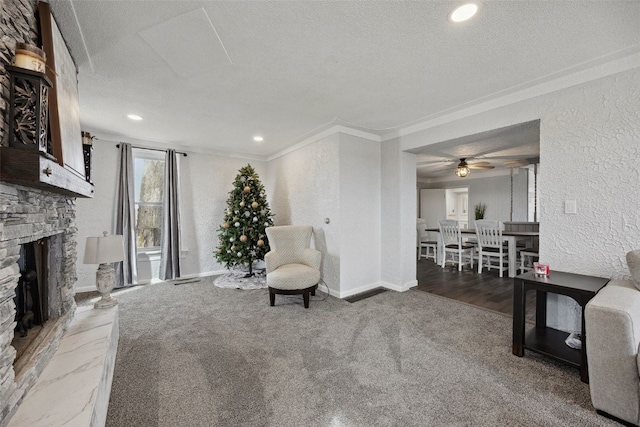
[[76, 140, 266, 292]]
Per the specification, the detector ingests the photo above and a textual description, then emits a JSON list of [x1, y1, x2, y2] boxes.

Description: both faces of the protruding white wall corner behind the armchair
[[267, 131, 381, 298]]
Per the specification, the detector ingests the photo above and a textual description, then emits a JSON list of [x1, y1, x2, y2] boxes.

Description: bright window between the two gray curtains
[[133, 149, 165, 252]]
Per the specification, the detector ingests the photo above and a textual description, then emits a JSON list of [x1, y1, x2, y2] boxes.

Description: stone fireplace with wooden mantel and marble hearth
[[0, 0, 118, 427]]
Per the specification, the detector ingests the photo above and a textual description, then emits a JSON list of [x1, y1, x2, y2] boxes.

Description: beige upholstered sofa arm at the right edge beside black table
[[585, 281, 640, 424]]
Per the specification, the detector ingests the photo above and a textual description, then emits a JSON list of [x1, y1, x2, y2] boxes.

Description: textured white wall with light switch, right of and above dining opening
[[401, 68, 640, 329]]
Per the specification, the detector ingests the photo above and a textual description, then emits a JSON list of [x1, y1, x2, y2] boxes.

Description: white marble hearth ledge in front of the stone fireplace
[[8, 306, 119, 427]]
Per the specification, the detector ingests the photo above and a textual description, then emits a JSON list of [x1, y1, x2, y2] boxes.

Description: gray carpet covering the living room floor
[[107, 279, 617, 427]]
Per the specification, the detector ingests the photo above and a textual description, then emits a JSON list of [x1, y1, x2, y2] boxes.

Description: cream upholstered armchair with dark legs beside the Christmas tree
[[264, 225, 322, 308]]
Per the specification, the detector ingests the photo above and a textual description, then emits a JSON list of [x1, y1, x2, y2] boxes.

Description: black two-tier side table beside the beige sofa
[[513, 271, 609, 383]]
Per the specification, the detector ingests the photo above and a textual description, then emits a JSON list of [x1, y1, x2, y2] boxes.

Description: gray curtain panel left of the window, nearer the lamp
[[114, 142, 138, 288]]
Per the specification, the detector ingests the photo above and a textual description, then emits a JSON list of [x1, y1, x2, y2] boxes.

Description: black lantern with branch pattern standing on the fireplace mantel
[[5, 65, 51, 153]]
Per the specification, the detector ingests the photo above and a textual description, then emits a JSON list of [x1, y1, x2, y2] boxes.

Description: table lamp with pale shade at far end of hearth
[[84, 231, 124, 308]]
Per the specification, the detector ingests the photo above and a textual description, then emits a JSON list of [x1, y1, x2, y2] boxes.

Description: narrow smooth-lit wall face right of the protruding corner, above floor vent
[[339, 134, 381, 295]]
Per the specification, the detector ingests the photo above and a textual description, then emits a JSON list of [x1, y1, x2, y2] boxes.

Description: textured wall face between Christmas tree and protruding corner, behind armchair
[[265, 134, 341, 295]]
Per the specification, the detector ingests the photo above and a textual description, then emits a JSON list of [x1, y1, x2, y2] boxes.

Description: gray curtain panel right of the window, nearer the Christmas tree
[[160, 150, 180, 280]]
